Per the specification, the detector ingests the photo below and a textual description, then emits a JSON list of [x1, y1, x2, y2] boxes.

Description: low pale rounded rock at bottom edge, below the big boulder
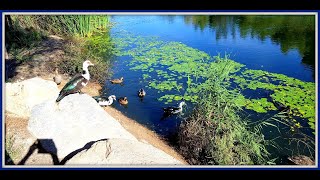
[[66, 139, 183, 166]]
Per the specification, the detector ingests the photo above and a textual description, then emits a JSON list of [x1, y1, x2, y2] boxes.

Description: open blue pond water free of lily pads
[[104, 15, 315, 162]]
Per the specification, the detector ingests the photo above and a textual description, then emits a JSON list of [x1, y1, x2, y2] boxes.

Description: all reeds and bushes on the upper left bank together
[[6, 15, 113, 83]]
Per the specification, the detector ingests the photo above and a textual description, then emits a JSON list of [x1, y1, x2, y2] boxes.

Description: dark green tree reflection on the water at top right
[[180, 15, 315, 70]]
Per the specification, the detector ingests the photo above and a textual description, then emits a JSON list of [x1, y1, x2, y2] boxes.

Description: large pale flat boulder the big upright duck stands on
[[28, 94, 138, 161]]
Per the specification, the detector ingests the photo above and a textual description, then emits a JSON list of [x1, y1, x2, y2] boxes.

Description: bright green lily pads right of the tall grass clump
[[231, 70, 315, 129]]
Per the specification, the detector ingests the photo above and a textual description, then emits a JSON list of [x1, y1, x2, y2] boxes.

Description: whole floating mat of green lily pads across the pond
[[113, 33, 315, 129]]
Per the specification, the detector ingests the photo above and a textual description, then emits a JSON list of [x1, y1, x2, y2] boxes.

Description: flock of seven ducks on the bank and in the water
[[54, 60, 186, 115]]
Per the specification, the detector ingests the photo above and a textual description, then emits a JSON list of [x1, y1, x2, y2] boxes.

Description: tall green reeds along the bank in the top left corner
[[5, 15, 110, 51]]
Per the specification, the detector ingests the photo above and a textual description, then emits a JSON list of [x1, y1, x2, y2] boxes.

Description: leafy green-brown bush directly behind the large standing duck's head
[[59, 31, 113, 84]]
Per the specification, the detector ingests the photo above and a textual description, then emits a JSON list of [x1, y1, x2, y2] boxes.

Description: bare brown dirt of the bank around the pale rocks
[[5, 36, 188, 165]]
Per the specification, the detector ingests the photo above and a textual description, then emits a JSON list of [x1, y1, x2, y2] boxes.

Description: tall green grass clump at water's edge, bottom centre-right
[[178, 58, 269, 165]]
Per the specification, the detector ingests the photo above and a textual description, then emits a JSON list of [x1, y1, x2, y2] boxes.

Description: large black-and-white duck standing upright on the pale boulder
[[56, 60, 94, 102]]
